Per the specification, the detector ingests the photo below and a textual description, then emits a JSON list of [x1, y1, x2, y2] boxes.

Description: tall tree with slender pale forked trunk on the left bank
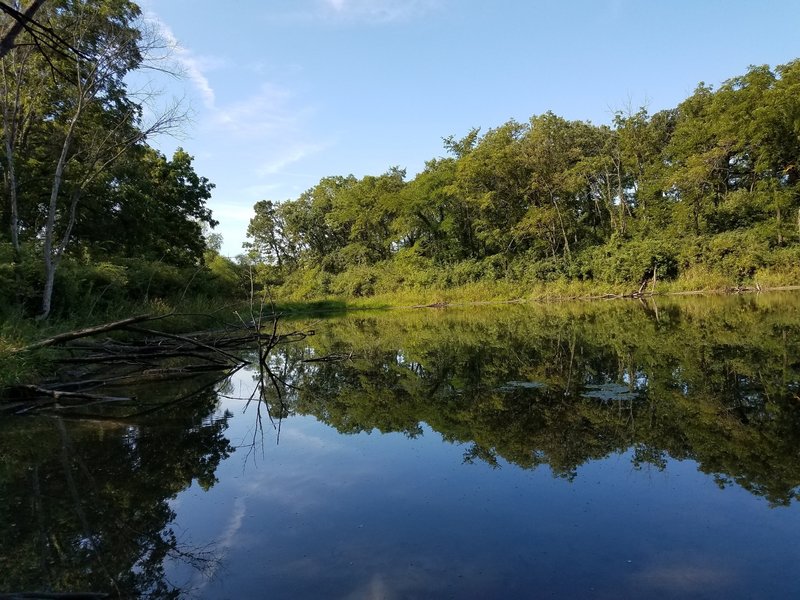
[[2, 0, 184, 318]]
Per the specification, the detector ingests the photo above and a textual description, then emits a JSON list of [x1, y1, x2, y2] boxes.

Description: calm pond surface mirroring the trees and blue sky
[[0, 294, 800, 598]]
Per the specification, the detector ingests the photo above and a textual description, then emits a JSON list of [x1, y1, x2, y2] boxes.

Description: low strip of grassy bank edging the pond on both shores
[[6, 279, 800, 388]]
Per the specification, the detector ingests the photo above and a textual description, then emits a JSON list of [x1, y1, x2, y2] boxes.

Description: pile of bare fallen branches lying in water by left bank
[[0, 307, 316, 418]]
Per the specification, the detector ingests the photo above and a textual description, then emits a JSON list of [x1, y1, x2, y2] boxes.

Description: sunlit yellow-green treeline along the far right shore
[[246, 60, 800, 297]]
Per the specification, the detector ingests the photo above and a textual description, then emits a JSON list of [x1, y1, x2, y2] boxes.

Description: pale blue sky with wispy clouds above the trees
[[141, 0, 800, 256]]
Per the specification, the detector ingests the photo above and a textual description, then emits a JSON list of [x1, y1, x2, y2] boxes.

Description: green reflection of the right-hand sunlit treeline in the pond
[[274, 295, 800, 505]]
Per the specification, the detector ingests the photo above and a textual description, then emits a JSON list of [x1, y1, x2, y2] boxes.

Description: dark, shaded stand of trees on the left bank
[[0, 0, 242, 317]]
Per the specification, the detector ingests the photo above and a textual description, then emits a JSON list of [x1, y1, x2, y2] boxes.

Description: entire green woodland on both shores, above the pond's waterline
[[0, 0, 800, 320]]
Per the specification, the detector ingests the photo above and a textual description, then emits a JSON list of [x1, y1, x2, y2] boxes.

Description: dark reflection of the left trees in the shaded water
[[0, 391, 231, 598]]
